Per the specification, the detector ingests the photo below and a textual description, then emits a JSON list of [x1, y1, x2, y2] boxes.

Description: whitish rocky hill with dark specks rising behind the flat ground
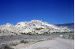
[[0, 20, 71, 35]]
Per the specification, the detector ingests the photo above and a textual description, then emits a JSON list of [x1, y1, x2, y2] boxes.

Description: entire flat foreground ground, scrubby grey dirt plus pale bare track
[[0, 34, 74, 49]]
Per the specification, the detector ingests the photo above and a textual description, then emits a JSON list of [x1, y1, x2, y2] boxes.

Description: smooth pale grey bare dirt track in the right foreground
[[24, 38, 74, 49]]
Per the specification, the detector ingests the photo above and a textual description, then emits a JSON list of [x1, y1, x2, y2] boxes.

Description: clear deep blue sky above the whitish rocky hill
[[0, 0, 74, 24]]
